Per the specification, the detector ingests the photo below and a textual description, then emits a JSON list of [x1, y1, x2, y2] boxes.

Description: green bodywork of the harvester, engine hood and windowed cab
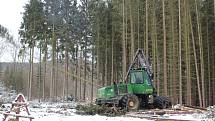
[[97, 69, 153, 99]]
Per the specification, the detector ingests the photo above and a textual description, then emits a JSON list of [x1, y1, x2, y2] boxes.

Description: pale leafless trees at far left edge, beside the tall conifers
[[0, 25, 23, 91]]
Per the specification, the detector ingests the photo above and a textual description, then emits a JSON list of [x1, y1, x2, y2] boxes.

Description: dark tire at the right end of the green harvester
[[153, 96, 171, 109]]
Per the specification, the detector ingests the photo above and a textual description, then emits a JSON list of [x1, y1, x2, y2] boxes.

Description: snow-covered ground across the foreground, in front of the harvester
[[0, 101, 215, 121]]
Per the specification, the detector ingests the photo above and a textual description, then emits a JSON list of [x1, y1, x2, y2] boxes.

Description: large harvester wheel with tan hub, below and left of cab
[[120, 94, 140, 110]]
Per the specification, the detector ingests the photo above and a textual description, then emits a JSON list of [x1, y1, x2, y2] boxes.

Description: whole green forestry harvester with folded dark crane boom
[[96, 49, 171, 110]]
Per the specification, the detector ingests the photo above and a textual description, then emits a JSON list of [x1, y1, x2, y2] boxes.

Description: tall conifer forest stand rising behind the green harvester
[[1, 0, 215, 107]]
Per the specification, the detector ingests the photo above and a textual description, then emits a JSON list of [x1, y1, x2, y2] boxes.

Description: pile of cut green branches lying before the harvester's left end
[[76, 104, 127, 117]]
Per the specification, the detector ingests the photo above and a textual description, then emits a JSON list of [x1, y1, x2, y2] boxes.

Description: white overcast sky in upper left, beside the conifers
[[0, 0, 29, 62]]
